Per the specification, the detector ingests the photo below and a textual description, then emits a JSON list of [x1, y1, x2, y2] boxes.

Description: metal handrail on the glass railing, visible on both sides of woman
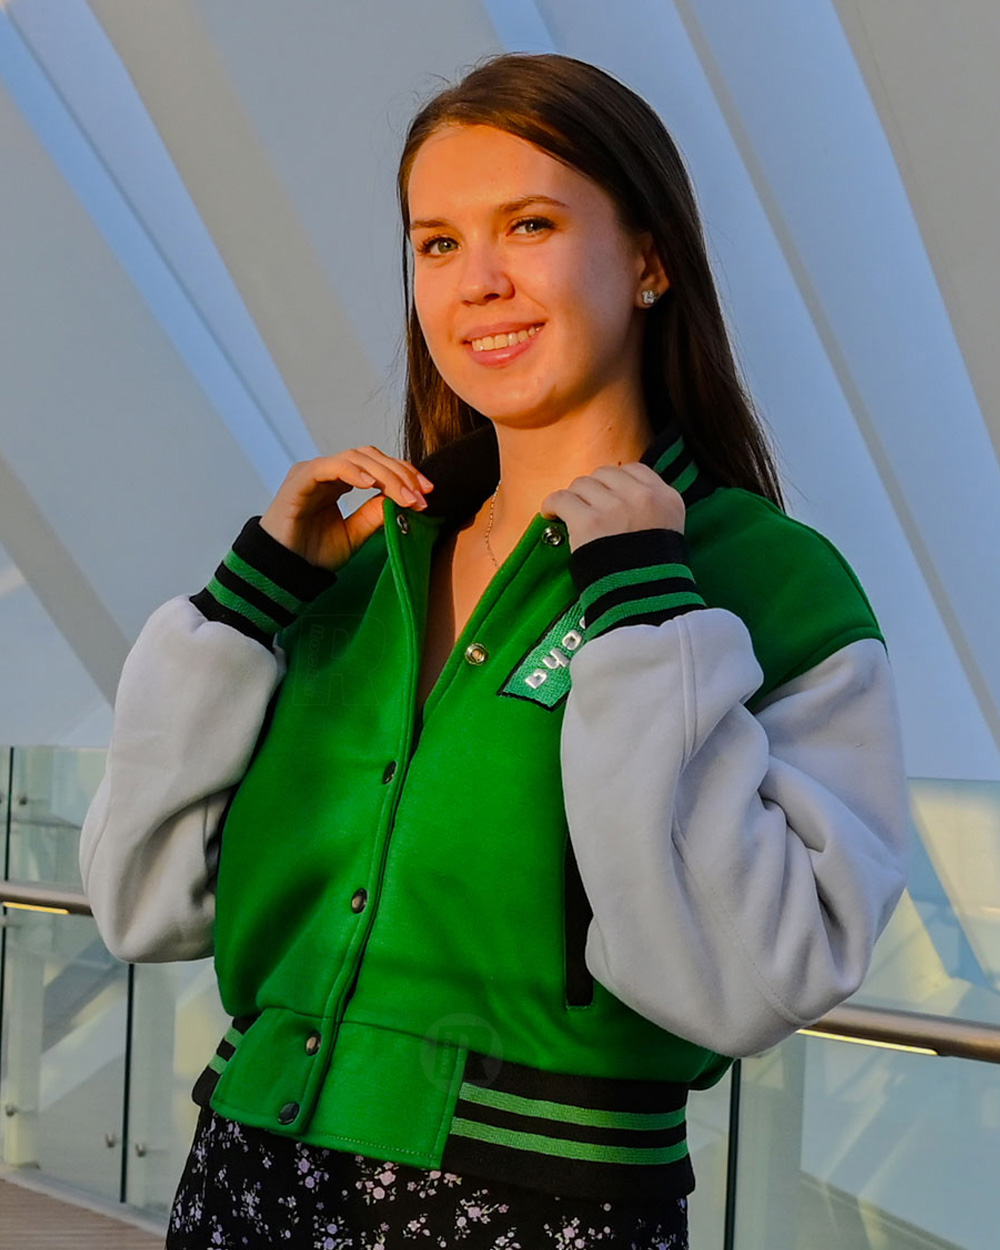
[[0, 881, 1000, 1064]]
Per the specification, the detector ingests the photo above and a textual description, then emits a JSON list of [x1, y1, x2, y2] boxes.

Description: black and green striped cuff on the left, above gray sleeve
[[191, 516, 336, 646]]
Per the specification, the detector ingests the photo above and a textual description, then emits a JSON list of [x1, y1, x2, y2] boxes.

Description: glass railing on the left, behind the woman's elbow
[[0, 749, 229, 1221]]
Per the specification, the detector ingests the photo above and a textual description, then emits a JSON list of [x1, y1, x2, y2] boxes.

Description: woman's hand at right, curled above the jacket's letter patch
[[539, 460, 685, 551]]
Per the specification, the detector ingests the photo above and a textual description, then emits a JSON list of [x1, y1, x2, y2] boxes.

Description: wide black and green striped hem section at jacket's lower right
[[441, 1051, 694, 1203]]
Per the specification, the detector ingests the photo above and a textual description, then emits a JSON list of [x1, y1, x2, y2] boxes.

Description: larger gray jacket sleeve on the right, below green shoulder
[[561, 609, 909, 1056]]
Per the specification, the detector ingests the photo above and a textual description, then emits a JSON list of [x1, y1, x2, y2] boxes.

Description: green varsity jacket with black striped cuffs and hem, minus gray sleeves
[[172, 426, 879, 1201]]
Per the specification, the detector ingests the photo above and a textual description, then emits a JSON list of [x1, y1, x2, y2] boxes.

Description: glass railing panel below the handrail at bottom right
[[735, 1036, 1000, 1250]]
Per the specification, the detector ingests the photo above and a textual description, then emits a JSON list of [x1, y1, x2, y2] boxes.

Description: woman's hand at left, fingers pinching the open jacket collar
[[260, 446, 434, 573]]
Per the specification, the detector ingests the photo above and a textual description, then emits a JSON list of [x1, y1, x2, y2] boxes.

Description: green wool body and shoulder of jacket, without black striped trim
[[211, 488, 880, 1168]]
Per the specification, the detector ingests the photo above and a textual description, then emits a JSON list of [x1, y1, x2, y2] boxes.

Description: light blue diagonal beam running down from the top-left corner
[[0, 0, 315, 489]]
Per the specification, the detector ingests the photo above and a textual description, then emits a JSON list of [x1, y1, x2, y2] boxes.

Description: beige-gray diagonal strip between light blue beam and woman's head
[[90, 0, 397, 451]]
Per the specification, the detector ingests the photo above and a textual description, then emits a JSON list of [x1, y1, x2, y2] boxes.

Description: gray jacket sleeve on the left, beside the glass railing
[[80, 598, 285, 963]]
